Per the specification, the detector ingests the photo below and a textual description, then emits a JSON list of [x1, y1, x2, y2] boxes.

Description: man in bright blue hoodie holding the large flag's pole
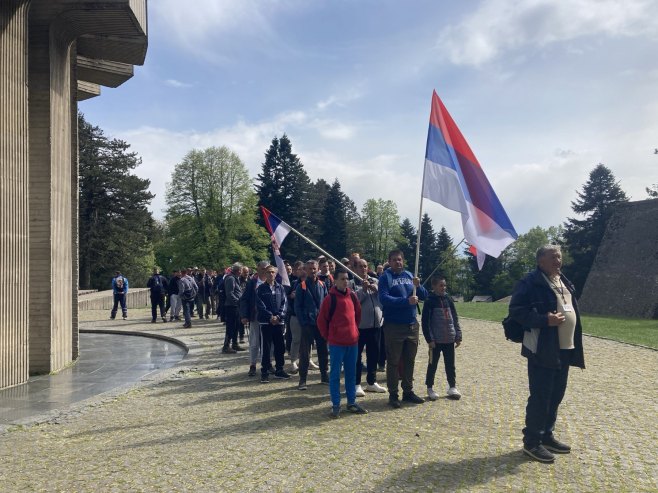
[[379, 249, 427, 408]]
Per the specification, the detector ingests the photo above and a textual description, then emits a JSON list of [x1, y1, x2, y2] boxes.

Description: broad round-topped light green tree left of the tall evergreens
[[166, 146, 269, 268]]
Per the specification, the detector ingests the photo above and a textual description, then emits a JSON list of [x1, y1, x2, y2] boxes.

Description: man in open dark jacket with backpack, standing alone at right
[[509, 245, 585, 463]]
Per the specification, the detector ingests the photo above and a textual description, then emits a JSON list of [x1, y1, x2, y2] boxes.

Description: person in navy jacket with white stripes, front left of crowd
[[256, 265, 290, 383]]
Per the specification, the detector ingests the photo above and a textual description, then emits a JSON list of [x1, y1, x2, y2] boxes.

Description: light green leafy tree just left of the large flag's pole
[[361, 199, 402, 263]]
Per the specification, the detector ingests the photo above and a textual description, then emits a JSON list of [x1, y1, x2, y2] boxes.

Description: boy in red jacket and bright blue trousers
[[317, 270, 368, 418]]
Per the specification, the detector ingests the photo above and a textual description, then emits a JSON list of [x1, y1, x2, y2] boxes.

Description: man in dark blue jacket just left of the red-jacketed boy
[[295, 260, 329, 390]]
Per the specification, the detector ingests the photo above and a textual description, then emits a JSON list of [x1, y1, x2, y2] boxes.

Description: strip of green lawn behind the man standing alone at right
[[455, 303, 658, 349]]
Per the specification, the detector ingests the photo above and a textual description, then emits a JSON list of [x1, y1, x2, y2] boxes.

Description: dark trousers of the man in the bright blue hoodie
[[384, 322, 418, 399]]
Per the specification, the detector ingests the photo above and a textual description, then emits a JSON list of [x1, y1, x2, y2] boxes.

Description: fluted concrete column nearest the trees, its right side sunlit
[[29, 15, 73, 373]]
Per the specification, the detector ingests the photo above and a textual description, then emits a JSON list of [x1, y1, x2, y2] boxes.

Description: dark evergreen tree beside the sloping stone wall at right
[[564, 164, 628, 296]]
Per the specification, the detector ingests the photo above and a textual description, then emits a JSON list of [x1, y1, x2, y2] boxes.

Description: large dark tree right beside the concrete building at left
[[78, 113, 155, 289]]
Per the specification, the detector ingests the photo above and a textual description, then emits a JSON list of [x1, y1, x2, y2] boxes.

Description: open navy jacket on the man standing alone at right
[[509, 268, 585, 368]]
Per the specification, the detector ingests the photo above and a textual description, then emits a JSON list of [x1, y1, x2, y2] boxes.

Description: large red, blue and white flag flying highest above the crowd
[[423, 91, 518, 269]]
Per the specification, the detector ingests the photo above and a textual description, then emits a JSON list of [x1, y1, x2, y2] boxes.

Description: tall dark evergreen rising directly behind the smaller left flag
[[256, 134, 310, 259]]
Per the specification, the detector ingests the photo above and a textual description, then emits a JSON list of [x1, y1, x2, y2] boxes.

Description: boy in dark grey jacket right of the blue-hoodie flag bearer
[[422, 277, 462, 401]]
